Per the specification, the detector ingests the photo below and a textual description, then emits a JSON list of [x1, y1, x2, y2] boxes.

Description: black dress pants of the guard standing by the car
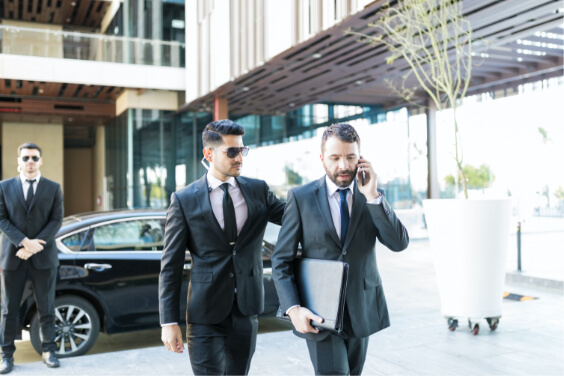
[[0, 256, 58, 358]]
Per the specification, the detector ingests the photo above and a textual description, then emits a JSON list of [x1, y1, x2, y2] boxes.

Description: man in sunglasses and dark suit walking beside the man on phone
[[159, 120, 284, 375]]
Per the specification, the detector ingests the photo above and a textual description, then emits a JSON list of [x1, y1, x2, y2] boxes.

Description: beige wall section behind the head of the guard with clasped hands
[[2, 122, 65, 192]]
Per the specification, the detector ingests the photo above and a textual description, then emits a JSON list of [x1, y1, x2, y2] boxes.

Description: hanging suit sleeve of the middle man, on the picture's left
[[159, 193, 188, 324]]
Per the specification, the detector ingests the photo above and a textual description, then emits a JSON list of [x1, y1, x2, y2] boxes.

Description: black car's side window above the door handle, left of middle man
[[92, 219, 163, 251]]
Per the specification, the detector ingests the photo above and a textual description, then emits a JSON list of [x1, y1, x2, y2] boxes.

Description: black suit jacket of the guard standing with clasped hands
[[0, 176, 63, 270]]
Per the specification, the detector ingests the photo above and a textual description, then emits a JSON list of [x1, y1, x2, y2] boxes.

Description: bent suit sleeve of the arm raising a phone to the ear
[[366, 196, 409, 252]]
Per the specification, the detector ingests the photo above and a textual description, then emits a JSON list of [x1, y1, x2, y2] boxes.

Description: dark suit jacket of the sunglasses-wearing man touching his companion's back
[[159, 175, 284, 324]]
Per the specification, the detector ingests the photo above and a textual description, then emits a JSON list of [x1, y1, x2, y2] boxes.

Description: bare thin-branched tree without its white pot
[[346, 0, 472, 198]]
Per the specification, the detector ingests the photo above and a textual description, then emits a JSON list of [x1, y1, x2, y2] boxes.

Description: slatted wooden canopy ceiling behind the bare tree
[[187, 0, 564, 115]]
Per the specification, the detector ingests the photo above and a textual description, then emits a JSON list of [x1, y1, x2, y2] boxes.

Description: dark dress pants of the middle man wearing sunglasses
[[187, 300, 258, 375]]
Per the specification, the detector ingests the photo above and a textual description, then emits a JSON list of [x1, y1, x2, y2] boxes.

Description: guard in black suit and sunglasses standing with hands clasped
[[0, 143, 63, 374]]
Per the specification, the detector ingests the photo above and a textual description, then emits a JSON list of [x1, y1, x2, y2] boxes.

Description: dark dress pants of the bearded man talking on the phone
[[306, 308, 369, 375]]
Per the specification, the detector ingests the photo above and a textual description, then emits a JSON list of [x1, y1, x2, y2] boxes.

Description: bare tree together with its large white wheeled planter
[[347, 0, 511, 334]]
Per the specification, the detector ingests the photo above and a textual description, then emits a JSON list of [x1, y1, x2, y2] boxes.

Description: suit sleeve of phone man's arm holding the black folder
[[272, 191, 302, 312]]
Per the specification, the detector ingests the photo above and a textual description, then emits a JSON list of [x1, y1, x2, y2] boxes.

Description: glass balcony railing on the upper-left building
[[0, 25, 185, 67]]
